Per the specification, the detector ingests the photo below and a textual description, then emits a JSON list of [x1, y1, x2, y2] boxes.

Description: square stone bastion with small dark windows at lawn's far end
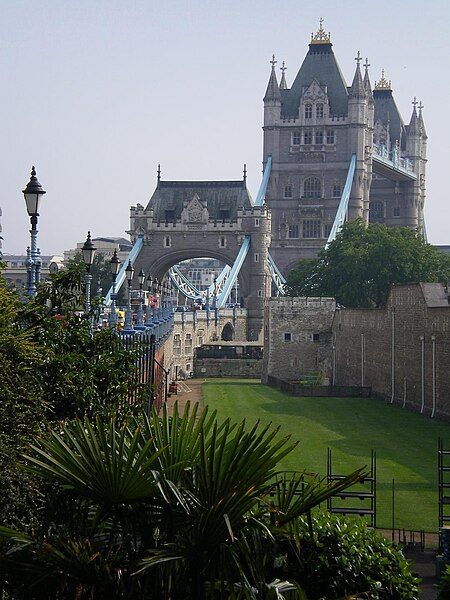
[[262, 297, 336, 382]]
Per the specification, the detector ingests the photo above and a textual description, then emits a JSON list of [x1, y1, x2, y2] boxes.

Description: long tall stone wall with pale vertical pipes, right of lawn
[[332, 284, 450, 419]]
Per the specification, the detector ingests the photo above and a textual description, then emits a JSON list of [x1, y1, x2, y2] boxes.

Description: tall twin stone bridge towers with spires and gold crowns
[[263, 20, 426, 275]]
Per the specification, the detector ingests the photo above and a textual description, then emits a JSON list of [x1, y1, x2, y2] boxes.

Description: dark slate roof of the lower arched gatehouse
[[146, 180, 253, 221]]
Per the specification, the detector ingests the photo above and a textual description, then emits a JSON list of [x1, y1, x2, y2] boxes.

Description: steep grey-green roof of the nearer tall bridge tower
[[281, 42, 348, 117]]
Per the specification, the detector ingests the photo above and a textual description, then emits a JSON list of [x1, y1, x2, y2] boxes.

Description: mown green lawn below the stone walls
[[202, 379, 450, 531]]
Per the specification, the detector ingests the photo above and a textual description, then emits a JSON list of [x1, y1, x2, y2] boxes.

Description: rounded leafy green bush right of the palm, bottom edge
[[297, 513, 418, 600]]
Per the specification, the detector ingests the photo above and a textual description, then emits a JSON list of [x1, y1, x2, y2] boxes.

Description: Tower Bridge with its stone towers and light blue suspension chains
[[110, 20, 427, 341]]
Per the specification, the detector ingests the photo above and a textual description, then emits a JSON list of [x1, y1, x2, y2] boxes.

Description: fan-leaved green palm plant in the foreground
[[0, 406, 362, 600]]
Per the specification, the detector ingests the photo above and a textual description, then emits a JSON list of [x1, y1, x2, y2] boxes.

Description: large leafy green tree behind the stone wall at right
[[287, 219, 450, 308]]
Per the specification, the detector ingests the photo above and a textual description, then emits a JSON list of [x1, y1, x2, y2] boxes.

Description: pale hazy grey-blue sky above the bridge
[[0, 0, 450, 254]]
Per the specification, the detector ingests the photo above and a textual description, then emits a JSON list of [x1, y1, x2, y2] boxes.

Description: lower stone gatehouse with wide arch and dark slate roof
[[128, 171, 271, 341]]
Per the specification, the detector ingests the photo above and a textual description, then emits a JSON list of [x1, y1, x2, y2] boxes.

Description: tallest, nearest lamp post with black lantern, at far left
[[22, 166, 46, 296]]
